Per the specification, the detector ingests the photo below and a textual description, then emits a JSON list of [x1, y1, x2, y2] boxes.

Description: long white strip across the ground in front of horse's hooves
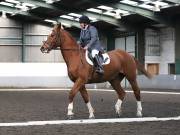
[[0, 116, 180, 127]]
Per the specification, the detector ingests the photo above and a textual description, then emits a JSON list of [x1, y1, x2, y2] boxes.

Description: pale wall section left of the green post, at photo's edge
[[0, 17, 22, 62]]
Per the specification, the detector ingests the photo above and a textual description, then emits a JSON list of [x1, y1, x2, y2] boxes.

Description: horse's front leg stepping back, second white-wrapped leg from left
[[80, 85, 95, 119]]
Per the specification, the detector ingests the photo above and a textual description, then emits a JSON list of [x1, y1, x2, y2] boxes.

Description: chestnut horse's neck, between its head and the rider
[[61, 32, 79, 66]]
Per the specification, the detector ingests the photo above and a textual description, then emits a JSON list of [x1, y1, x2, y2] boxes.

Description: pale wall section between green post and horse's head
[[23, 24, 63, 62]]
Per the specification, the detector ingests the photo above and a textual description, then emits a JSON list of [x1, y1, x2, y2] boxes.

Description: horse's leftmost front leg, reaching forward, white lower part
[[67, 78, 84, 119]]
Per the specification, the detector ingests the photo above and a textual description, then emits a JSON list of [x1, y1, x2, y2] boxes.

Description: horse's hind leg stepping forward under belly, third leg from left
[[110, 75, 126, 117]]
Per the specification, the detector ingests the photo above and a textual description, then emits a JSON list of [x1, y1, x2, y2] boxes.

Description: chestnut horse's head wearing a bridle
[[40, 24, 61, 53]]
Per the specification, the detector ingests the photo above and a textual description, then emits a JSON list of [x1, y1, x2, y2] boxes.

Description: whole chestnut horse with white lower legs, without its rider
[[40, 24, 151, 119]]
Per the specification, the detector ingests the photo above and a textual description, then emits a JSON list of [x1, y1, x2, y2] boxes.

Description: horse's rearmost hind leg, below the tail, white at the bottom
[[129, 79, 142, 117]]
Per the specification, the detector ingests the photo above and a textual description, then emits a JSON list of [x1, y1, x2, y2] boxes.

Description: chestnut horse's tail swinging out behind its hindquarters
[[134, 58, 153, 79]]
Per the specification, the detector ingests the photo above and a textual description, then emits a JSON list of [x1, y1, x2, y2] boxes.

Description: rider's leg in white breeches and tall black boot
[[91, 49, 104, 74]]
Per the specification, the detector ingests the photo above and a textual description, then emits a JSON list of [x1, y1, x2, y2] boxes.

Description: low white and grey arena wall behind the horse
[[0, 63, 180, 89]]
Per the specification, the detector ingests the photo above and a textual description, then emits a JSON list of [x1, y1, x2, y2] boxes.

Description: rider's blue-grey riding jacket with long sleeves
[[80, 25, 103, 52]]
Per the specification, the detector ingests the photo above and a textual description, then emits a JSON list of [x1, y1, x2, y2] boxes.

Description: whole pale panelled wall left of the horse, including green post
[[0, 17, 67, 62]]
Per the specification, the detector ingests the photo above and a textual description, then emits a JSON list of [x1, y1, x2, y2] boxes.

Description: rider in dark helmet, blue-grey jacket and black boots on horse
[[79, 15, 104, 74]]
